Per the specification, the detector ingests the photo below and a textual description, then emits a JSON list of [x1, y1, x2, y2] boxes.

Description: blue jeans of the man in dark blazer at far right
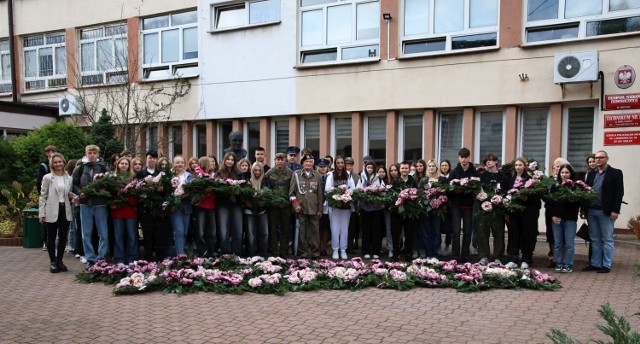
[[587, 209, 614, 269]]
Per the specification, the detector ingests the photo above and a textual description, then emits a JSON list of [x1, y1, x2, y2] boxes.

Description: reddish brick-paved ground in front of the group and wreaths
[[0, 242, 640, 344]]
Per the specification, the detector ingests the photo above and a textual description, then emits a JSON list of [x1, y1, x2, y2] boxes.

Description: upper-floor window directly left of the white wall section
[[142, 11, 198, 80]]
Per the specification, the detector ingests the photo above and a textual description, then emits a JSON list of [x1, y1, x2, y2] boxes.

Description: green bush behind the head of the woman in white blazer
[[9, 122, 89, 189]]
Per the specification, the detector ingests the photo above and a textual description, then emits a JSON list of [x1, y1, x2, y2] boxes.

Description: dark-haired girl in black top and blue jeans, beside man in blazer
[[546, 165, 580, 272]]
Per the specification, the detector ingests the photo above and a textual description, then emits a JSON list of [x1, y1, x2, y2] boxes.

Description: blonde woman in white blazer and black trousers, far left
[[39, 153, 75, 273]]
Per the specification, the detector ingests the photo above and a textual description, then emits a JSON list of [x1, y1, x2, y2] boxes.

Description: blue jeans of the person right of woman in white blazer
[[80, 204, 109, 263]]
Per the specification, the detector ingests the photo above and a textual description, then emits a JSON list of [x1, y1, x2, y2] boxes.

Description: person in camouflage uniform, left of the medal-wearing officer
[[264, 153, 293, 258]]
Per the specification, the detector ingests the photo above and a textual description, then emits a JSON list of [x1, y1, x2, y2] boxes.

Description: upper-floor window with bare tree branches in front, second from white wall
[[80, 24, 129, 85]]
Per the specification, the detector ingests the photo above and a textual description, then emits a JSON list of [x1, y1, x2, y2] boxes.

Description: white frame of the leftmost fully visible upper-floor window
[[21, 31, 67, 92]]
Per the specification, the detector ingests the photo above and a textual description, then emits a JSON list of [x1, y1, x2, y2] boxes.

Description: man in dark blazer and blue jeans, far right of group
[[581, 150, 624, 273]]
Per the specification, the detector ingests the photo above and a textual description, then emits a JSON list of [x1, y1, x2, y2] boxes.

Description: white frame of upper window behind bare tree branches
[[78, 23, 129, 86]]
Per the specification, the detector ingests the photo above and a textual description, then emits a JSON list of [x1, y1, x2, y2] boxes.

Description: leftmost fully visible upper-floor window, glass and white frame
[[22, 32, 67, 91]]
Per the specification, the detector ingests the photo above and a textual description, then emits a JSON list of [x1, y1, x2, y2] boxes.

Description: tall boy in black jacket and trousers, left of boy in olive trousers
[[449, 148, 478, 262]]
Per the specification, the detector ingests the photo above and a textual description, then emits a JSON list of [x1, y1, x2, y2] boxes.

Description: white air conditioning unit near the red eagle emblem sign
[[553, 50, 598, 84]]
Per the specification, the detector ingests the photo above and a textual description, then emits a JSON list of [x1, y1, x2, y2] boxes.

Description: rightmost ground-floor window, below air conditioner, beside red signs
[[564, 106, 595, 172]]
